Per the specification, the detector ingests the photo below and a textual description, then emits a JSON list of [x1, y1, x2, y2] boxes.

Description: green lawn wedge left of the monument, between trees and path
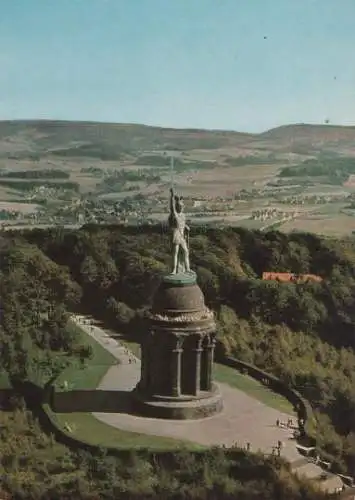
[[56, 322, 118, 390]]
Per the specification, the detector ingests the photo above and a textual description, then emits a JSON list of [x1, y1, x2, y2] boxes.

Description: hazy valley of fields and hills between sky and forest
[[0, 121, 355, 235]]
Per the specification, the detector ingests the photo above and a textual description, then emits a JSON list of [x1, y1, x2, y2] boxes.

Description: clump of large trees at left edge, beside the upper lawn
[[0, 238, 81, 385]]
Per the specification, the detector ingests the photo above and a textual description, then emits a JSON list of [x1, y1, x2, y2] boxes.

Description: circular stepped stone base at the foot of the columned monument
[[132, 385, 223, 420]]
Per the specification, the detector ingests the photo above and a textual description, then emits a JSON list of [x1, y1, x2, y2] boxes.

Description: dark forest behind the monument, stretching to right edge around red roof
[[28, 226, 355, 474]]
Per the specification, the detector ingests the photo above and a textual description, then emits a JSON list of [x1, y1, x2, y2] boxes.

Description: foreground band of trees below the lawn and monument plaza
[[0, 408, 329, 500]]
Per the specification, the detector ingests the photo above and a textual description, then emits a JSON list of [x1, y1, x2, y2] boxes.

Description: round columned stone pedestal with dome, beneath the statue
[[133, 273, 223, 419]]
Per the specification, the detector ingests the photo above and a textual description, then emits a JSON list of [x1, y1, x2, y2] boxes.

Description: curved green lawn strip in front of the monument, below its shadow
[[52, 413, 203, 450]]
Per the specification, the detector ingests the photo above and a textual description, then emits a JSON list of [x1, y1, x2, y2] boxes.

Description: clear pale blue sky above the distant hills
[[0, 0, 355, 132]]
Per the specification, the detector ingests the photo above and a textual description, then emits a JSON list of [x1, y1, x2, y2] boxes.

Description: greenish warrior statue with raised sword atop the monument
[[169, 188, 190, 274]]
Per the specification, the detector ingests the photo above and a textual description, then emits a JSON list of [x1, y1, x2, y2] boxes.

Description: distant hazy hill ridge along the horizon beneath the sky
[[0, 120, 355, 159]]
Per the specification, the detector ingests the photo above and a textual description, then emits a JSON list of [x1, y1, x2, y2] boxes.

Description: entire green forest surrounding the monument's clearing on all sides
[[0, 226, 355, 500]]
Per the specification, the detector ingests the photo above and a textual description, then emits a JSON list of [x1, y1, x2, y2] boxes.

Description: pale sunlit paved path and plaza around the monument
[[72, 315, 343, 492]]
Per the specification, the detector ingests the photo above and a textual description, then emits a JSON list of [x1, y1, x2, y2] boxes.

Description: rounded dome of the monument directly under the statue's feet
[[151, 279, 206, 314]]
